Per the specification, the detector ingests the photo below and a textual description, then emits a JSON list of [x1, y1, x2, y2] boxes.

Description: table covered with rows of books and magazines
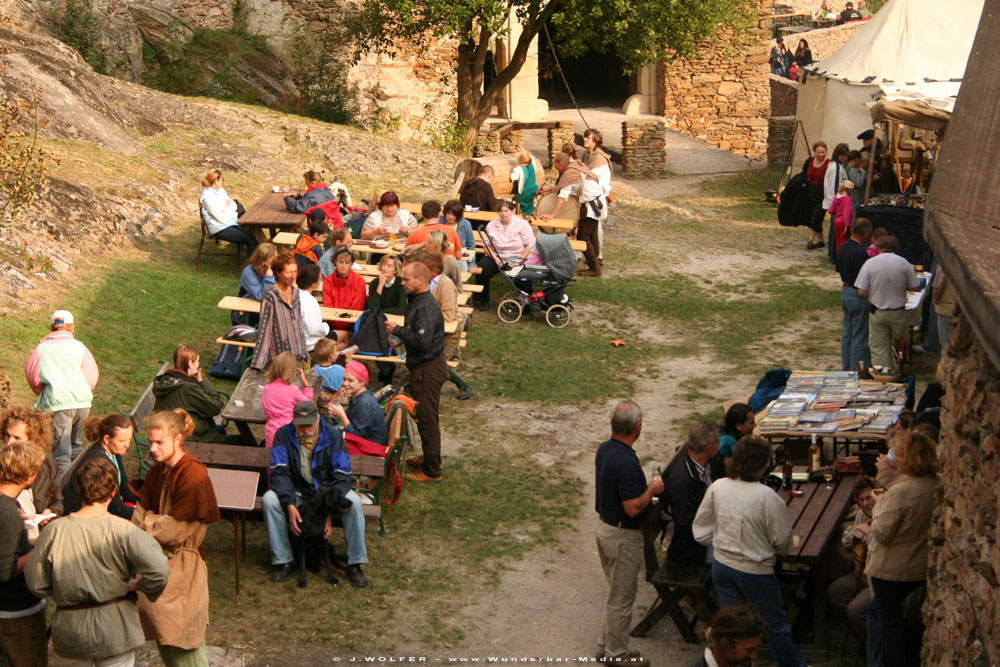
[[757, 371, 907, 448]]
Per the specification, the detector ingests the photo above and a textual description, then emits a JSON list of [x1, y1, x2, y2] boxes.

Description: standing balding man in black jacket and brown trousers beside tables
[[385, 262, 448, 482]]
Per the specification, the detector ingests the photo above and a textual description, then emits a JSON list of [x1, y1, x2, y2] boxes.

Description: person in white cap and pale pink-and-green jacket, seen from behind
[[24, 310, 100, 472]]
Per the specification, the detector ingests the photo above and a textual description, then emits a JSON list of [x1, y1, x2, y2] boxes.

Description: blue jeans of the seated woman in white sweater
[[712, 561, 806, 667]]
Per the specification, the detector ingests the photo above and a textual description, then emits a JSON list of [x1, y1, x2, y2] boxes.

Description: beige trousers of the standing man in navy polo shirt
[[597, 521, 643, 658]]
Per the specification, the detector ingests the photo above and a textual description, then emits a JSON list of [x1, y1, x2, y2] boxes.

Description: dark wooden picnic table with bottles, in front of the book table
[[778, 467, 857, 657]]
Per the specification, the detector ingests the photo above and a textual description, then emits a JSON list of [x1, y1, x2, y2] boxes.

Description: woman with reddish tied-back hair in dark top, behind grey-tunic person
[[63, 412, 135, 519]]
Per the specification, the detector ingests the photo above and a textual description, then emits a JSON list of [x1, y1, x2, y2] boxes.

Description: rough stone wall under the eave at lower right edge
[[922, 315, 1000, 667]]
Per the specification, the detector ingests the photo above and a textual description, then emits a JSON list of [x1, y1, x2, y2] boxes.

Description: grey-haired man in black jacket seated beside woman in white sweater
[[661, 419, 719, 566]]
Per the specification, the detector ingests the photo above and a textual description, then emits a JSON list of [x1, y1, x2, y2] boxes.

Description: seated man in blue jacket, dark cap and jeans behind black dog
[[262, 401, 368, 588]]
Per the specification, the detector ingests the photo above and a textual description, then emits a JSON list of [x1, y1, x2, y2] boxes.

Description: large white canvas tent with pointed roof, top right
[[793, 0, 984, 168]]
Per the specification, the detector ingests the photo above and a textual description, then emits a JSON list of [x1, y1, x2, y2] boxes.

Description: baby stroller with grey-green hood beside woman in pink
[[482, 230, 576, 329]]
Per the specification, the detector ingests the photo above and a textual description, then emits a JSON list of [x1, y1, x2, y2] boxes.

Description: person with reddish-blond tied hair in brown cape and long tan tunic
[[130, 408, 221, 667]]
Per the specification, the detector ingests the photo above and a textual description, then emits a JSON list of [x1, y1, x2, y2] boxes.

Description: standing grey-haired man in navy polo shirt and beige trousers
[[594, 401, 663, 667]]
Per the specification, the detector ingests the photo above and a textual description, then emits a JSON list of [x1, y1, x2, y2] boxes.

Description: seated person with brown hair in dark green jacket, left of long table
[[153, 343, 226, 442]]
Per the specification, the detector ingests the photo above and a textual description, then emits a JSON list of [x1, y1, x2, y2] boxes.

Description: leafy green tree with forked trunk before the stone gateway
[[351, 0, 757, 145]]
